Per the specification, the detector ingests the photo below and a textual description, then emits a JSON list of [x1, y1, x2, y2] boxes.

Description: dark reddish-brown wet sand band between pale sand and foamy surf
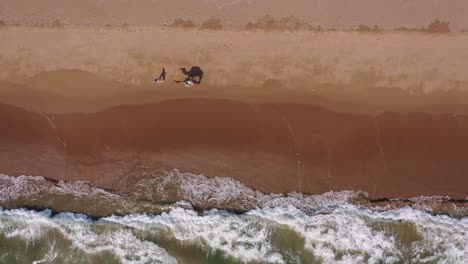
[[2, 99, 468, 199]]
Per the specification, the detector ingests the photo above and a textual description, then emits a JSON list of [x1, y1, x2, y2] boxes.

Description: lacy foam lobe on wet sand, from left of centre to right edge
[[133, 169, 468, 216]]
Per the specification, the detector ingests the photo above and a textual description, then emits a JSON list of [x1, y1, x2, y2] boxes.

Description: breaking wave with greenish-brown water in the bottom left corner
[[0, 209, 177, 263]]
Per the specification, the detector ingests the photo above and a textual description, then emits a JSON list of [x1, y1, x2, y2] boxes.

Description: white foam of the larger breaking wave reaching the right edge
[[105, 204, 468, 263]]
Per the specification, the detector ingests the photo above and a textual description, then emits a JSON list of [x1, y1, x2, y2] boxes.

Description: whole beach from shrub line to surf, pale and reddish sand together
[[0, 26, 468, 198]]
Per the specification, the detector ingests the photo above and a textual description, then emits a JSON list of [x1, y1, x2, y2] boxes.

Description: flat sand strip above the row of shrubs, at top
[[0, 0, 468, 29]]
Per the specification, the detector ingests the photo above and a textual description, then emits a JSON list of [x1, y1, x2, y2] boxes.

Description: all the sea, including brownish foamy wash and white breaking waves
[[0, 170, 468, 264]]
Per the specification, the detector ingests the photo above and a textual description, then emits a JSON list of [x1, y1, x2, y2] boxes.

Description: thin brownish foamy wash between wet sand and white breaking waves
[[0, 169, 468, 220]]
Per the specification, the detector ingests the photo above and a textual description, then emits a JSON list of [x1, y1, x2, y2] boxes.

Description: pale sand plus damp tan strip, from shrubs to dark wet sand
[[0, 27, 468, 113]]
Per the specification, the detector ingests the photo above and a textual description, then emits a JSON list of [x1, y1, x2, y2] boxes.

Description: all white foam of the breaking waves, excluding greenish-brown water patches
[[0, 204, 468, 263]]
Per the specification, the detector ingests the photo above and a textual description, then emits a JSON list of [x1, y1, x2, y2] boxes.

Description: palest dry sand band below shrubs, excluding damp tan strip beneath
[[0, 27, 468, 88]]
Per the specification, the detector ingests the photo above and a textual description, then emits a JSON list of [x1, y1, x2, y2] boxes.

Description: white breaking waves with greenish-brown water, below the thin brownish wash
[[0, 204, 468, 263]]
